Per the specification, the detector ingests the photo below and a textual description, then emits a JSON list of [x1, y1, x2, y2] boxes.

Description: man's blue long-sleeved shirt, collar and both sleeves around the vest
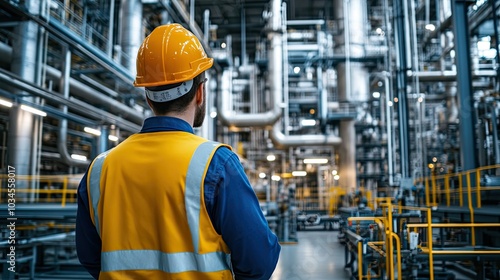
[[76, 117, 281, 280]]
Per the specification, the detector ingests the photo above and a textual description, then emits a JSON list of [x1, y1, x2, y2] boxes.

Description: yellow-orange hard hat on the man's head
[[134, 23, 214, 87]]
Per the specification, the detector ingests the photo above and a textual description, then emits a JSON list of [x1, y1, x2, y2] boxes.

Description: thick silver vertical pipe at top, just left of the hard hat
[[120, 0, 144, 73]]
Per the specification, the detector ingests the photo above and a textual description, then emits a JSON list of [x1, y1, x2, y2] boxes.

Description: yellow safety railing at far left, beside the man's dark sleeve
[[0, 174, 83, 206]]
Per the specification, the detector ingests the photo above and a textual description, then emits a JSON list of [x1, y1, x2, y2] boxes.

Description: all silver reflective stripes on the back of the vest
[[89, 141, 231, 273]]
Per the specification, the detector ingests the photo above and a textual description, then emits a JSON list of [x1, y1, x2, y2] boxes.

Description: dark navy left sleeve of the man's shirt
[[75, 174, 101, 279]]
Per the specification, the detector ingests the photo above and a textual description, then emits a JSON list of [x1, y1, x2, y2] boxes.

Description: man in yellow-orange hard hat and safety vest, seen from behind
[[76, 24, 281, 280]]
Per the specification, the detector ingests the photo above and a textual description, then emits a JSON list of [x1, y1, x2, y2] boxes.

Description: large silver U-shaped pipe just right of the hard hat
[[217, 0, 283, 127]]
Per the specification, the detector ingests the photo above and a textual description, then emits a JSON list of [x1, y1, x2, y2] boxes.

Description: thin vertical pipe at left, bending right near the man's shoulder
[[57, 46, 90, 168]]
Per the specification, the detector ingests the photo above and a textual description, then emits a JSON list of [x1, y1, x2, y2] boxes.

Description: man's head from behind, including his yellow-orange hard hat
[[134, 23, 213, 115]]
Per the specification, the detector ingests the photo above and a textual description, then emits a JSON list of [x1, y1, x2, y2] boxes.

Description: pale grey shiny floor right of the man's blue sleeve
[[271, 231, 349, 280]]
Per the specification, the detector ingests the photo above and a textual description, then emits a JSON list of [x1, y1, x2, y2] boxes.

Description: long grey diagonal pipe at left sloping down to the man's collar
[[0, 69, 140, 132]]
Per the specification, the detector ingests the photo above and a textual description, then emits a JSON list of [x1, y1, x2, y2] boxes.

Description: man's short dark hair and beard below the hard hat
[[146, 72, 205, 115]]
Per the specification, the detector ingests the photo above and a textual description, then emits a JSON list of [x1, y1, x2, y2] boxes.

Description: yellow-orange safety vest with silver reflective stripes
[[87, 131, 233, 280]]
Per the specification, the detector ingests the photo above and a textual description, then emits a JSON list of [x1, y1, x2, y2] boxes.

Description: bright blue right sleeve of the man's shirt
[[205, 148, 281, 280]]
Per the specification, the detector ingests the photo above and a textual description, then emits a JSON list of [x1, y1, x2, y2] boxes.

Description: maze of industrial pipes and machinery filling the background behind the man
[[0, 0, 500, 280]]
